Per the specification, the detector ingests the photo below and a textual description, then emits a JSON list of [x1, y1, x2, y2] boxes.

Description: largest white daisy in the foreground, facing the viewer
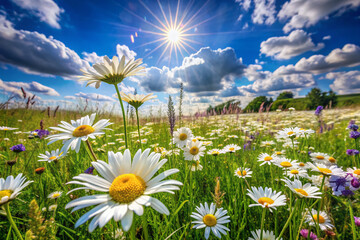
[[66, 149, 182, 232]]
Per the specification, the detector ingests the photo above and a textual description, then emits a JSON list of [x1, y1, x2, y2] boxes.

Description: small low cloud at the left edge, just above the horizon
[[0, 79, 60, 97]]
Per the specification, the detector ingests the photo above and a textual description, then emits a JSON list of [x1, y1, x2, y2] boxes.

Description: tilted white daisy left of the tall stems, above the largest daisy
[[47, 113, 112, 153]]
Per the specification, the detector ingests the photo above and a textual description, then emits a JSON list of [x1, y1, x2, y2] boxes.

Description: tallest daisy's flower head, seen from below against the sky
[[79, 55, 145, 88]]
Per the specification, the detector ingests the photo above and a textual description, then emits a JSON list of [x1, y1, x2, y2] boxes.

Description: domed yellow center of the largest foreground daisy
[[109, 173, 146, 203]]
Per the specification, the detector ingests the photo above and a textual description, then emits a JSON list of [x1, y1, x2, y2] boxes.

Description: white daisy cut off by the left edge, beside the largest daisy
[[0, 173, 33, 206]]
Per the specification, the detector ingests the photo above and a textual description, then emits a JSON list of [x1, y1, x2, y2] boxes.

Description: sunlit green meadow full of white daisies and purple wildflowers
[[0, 108, 360, 239]]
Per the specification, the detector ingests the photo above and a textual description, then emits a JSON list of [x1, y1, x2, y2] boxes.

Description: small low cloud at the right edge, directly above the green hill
[[326, 71, 360, 94]]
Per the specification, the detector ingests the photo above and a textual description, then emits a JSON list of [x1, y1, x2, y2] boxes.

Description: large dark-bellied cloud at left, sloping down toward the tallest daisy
[[0, 15, 87, 78]]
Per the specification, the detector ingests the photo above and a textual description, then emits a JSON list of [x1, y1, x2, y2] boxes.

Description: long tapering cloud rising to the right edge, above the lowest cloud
[[274, 44, 360, 75]]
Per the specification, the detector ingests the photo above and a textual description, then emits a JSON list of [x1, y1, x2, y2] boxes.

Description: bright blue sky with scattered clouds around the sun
[[0, 0, 360, 112]]
